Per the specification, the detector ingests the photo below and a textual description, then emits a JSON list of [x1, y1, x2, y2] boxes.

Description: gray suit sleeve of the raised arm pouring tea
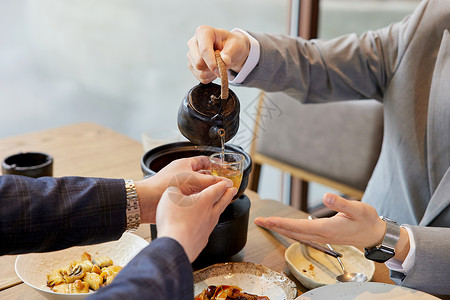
[[237, 2, 426, 103]]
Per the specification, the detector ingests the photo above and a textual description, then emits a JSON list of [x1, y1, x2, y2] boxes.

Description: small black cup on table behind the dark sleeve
[[2, 152, 53, 178]]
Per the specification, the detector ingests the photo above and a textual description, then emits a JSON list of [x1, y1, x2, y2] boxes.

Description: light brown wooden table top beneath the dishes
[[0, 123, 392, 299]]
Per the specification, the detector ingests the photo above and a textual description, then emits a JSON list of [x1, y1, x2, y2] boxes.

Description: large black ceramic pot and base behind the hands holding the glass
[[141, 142, 252, 268]]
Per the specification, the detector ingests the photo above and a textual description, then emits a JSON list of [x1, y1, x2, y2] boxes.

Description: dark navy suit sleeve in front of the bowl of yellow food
[[88, 238, 194, 300]]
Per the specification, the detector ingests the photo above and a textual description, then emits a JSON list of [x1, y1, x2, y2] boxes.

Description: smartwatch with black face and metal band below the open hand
[[364, 216, 400, 263]]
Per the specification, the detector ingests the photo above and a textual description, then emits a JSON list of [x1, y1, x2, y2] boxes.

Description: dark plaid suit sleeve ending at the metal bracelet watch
[[0, 175, 126, 255]]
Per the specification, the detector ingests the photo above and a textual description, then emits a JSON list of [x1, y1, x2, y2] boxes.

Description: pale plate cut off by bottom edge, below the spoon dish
[[295, 282, 439, 300]]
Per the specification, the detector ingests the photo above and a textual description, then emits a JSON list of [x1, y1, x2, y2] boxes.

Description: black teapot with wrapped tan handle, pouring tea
[[178, 51, 240, 146]]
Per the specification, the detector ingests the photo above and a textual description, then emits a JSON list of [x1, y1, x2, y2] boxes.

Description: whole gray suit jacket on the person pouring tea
[[243, 0, 450, 294]]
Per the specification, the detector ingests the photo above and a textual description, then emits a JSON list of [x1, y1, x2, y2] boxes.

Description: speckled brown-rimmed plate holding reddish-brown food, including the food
[[194, 262, 297, 300]]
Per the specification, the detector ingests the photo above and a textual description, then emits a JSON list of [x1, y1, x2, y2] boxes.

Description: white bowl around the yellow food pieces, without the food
[[15, 232, 148, 300]]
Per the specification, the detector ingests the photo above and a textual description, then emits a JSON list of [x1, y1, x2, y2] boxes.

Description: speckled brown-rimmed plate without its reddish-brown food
[[194, 262, 297, 300]]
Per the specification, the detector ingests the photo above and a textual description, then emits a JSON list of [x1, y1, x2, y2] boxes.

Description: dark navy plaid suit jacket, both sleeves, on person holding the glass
[[0, 175, 194, 300]]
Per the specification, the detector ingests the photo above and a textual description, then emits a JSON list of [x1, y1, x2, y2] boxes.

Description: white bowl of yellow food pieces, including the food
[[15, 232, 148, 299]]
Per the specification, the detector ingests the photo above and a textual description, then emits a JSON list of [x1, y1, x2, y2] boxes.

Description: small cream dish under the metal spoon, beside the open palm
[[285, 243, 375, 289]]
